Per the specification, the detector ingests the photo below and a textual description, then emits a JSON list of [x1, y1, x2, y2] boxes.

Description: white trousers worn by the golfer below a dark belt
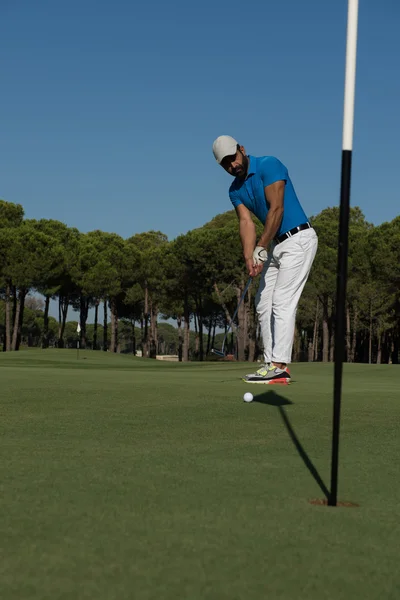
[[255, 229, 318, 363]]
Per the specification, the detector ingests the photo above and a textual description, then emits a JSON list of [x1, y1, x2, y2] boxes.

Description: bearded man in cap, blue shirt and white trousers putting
[[213, 135, 318, 383]]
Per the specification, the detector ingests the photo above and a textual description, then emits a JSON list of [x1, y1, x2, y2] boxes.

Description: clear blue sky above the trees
[[0, 0, 400, 244]]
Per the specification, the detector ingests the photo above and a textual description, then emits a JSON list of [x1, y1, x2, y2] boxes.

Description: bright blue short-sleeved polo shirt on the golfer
[[229, 156, 308, 235]]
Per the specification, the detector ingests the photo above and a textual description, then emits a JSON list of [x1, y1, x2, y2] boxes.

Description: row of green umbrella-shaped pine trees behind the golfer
[[0, 200, 400, 363]]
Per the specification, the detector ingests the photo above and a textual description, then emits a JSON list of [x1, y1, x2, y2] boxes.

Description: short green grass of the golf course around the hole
[[0, 350, 400, 600]]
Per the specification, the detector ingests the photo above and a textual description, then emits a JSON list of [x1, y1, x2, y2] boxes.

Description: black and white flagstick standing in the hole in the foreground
[[328, 0, 358, 506]]
